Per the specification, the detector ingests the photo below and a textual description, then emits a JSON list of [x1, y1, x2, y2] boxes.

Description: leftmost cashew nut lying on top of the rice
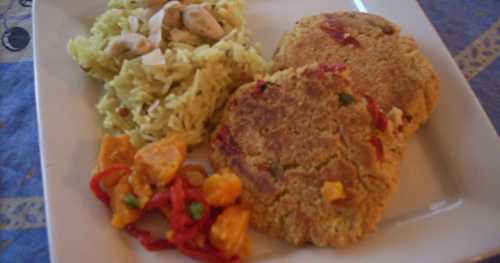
[[104, 33, 153, 57]]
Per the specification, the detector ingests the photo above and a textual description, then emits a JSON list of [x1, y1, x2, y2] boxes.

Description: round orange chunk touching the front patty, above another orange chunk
[[203, 169, 242, 206]]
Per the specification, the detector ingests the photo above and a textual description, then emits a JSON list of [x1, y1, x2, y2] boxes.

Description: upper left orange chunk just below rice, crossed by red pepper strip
[[98, 134, 136, 188]]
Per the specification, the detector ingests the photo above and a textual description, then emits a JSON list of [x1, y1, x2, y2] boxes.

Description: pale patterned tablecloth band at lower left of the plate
[[0, 197, 45, 230]]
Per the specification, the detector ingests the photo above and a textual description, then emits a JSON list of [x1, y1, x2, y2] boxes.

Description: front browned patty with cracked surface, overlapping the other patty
[[210, 64, 403, 246]]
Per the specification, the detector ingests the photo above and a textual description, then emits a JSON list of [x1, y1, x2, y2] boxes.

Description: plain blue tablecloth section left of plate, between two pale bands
[[0, 61, 43, 198]]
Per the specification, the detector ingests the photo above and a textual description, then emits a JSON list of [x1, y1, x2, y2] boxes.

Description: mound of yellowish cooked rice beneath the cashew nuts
[[68, 0, 268, 145]]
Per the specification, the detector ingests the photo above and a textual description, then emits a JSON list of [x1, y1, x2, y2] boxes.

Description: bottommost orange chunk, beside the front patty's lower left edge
[[210, 205, 250, 257]]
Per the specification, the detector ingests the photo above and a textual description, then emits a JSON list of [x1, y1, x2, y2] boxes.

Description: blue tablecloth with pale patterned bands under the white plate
[[0, 0, 500, 263]]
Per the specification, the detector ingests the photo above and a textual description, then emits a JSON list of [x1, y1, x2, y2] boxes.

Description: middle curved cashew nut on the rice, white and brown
[[148, 1, 182, 47]]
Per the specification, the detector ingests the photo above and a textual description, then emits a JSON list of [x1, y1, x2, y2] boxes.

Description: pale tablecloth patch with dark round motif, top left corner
[[0, 0, 32, 62]]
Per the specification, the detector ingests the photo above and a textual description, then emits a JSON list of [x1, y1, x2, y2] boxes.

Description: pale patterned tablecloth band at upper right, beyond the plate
[[455, 19, 500, 80]]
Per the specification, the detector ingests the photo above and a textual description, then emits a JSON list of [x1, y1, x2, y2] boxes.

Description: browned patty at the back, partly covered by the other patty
[[274, 12, 439, 135]]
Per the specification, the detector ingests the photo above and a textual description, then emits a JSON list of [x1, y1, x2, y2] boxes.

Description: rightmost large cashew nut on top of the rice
[[182, 4, 224, 40]]
